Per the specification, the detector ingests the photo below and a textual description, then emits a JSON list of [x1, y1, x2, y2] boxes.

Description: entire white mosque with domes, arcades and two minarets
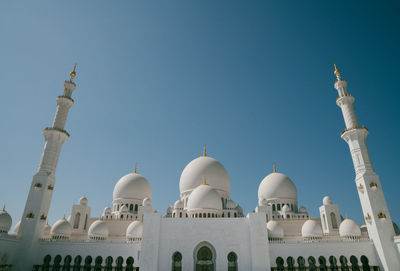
[[0, 65, 400, 271]]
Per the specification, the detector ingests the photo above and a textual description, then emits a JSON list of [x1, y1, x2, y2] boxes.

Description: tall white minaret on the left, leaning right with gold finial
[[13, 65, 76, 270]]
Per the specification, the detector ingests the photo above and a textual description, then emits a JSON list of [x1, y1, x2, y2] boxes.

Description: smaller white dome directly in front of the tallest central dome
[[187, 184, 222, 211]]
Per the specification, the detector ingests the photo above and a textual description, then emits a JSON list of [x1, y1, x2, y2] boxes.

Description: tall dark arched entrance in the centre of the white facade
[[193, 242, 216, 271]]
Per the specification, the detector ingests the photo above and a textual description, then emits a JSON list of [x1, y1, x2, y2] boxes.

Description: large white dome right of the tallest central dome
[[258, 172, 297, 201]]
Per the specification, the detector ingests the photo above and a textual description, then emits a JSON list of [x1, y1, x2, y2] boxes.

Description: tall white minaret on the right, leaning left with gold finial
[[334, 64, 400, 271]]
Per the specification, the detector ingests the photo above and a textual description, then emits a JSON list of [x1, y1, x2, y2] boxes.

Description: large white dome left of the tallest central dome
[[113, 173, 151, 200]]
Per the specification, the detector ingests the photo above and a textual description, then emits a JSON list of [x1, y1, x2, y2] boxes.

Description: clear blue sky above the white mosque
[[0, 0, 400, 230]]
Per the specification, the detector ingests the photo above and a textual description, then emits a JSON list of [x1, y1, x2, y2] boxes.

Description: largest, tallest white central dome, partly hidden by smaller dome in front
[[179, 156, 231, 195]]
